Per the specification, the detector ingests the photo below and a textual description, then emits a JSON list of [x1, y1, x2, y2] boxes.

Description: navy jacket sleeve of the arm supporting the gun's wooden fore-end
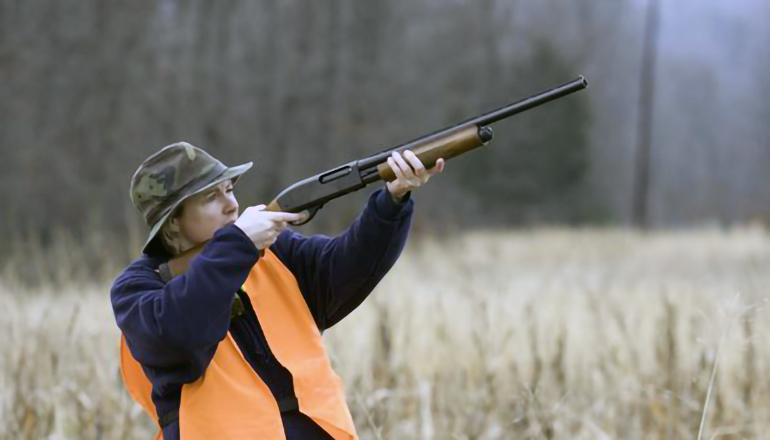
[[273, 188, 414, 331]]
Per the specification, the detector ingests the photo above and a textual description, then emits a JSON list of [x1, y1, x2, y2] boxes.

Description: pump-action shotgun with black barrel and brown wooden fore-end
[[159, 75, 588, 282]]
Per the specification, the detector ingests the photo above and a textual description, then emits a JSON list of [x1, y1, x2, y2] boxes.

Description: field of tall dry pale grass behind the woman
[[0, 227, 770, 440]]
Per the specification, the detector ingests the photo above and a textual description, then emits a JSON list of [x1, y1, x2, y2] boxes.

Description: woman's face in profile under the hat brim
[[175, 180, 238, 248]]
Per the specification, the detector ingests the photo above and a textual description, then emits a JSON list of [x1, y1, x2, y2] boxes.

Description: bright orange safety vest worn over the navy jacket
[[120, 249, 358, 440]]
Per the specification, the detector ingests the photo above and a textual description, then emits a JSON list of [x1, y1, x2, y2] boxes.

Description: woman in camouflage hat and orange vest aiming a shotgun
[[110, 142, 444, 440]]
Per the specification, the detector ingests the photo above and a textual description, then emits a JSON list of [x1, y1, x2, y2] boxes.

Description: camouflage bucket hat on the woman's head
[[130, 142, 252, 254]]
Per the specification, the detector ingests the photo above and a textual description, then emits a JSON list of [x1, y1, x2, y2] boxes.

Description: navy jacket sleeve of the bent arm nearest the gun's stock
[[110, 225, 259, 372]]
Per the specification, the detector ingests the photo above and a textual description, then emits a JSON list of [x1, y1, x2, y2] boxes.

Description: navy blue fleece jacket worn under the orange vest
[[110, 188, 414, 440]]
